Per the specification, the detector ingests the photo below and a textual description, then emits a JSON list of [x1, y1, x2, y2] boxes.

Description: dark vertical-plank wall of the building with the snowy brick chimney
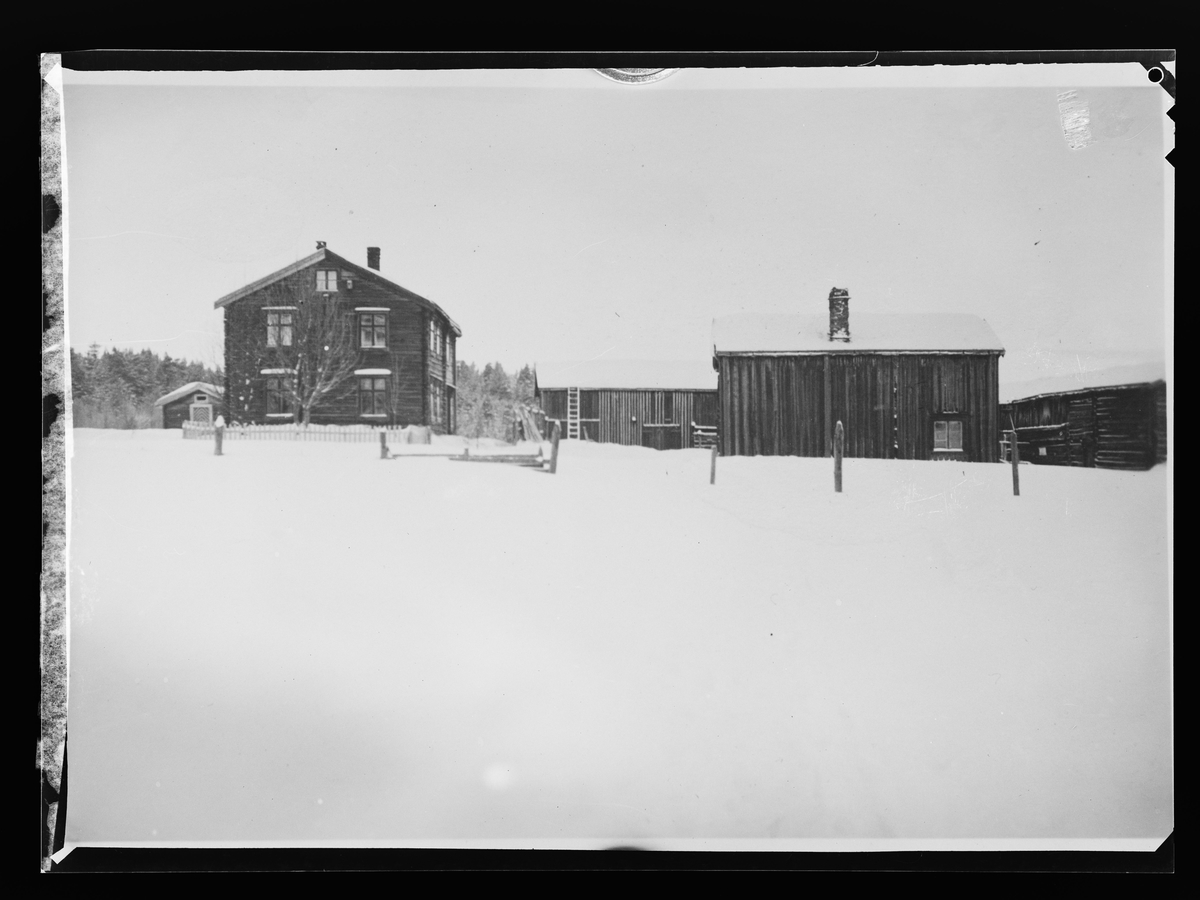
[[718, 353, 1000, 462]]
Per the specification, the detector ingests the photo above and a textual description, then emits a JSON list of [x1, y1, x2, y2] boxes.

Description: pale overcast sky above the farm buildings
[[58, 64, 1174, 382]]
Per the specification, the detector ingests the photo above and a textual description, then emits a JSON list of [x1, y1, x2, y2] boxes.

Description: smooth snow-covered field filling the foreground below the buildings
[[67, 431, 1174, 846]]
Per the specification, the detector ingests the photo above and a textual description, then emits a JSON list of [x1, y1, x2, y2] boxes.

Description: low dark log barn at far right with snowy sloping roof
[[1000, 364, 1166, 469]]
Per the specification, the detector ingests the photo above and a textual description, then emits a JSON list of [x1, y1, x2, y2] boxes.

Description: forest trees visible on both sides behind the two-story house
[[71, 344, 534, 440]]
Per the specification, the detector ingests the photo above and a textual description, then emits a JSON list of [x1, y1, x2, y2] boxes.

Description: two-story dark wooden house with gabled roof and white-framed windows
[[215, 241, 462, 433]]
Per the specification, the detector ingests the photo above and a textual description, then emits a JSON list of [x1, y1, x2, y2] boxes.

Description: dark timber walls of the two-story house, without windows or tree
[[221, 264, 454, 432]]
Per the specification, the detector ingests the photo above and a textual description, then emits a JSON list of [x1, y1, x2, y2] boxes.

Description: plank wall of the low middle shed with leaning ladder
[[538, 389, 718, 448]]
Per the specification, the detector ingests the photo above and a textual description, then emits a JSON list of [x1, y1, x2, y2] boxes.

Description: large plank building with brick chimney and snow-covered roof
[[713, 288, 1004, 462]]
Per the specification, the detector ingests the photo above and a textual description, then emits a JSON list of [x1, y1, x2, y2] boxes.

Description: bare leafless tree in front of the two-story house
[[264, 272, 359, 425]]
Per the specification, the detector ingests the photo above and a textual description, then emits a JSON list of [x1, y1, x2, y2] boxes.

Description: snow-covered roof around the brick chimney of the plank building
[[713, 313, 1004, 354]]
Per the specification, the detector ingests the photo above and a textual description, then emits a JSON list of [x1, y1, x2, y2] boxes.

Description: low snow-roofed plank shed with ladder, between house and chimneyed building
[[534, 360, 716, 450]]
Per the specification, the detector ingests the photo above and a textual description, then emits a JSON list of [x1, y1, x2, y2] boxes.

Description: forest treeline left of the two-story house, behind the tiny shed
[[71, 344, 223, 428]]
